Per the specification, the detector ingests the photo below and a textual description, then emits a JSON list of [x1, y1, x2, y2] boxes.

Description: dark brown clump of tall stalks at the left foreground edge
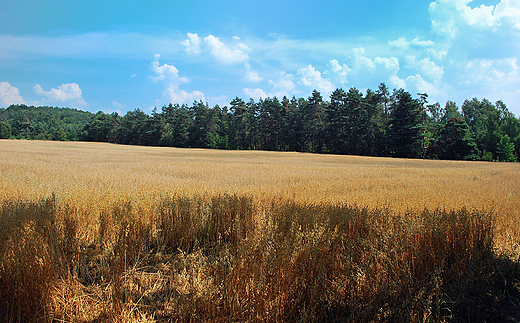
[[0, 197, 61, 322]]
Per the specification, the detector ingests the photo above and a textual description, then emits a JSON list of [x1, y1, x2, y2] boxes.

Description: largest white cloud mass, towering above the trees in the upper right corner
[[422, 0, 520, 110]]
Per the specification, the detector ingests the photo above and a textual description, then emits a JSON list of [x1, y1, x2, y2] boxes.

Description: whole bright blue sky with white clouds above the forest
[[0, 0, 520, 116]]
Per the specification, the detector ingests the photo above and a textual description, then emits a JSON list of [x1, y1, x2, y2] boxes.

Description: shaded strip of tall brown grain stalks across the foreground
[[0, 195, 520, 322]]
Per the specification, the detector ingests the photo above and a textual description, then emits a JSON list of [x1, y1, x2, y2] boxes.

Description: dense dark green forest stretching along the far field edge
[[0, 83, 520, 162]]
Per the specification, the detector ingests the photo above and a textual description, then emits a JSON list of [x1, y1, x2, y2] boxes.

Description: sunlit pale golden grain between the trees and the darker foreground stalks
[[0, 140, 520, 248]]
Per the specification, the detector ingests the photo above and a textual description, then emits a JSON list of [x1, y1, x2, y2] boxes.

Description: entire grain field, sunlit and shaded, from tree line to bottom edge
[[0, 140, 520, 322]]
